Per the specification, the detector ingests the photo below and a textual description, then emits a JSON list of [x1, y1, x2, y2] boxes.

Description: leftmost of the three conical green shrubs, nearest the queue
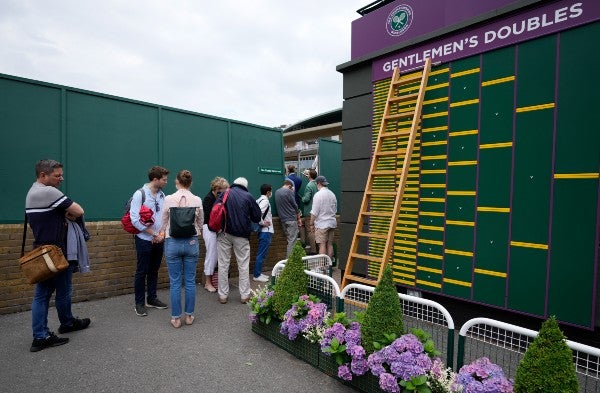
[[272, 242, 308, 319]]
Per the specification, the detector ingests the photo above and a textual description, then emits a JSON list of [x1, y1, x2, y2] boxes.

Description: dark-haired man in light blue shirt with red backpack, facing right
[[129, 166, 169, 317]]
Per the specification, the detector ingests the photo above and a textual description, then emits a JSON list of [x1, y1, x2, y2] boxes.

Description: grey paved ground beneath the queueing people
[[0, 274, 349, 393]]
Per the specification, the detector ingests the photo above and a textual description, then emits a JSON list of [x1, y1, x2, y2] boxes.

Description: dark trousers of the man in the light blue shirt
[[133, 236, 164, 304]]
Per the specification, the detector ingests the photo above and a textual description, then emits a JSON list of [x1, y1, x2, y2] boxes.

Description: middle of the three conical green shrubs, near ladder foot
[[360, 265, 404, 353]]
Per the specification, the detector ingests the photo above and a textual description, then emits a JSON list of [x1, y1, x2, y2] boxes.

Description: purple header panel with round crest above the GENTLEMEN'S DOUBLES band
[[351, 0, 518, 60]]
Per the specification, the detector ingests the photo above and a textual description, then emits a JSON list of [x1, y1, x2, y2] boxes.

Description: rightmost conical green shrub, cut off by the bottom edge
[[514, 317, 579, 393]]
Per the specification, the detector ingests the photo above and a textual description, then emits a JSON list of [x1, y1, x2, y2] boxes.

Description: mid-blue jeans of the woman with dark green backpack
[[165, 236, 200, 318]]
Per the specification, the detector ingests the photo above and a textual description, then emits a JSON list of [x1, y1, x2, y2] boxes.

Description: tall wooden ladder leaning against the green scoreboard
[[342, 59, 431, 288]]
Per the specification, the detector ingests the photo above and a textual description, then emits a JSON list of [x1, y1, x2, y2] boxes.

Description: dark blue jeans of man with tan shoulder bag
[[31, 264, 74, 339]]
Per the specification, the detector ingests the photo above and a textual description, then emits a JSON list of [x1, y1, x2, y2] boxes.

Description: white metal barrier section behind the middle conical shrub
[[336, 284, 454, 367]]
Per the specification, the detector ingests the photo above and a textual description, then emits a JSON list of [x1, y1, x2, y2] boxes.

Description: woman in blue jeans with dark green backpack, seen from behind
[[161, 170, 204, 328]]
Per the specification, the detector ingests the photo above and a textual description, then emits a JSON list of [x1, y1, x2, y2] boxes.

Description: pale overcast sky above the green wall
[[0, 0, 371, 126]]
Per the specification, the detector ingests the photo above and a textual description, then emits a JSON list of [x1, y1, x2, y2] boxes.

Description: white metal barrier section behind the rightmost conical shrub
[[456, 318, 600, 393]]
